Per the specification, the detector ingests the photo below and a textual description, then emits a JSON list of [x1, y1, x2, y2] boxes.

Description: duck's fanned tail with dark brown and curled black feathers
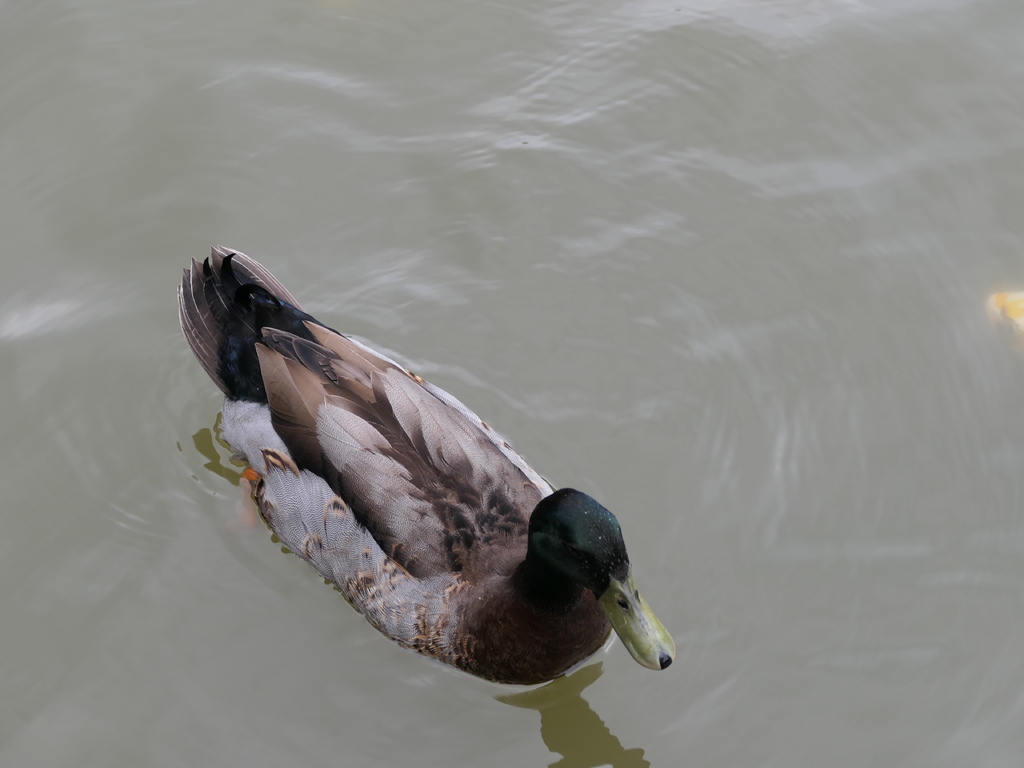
[[178, 247, 315, 402]]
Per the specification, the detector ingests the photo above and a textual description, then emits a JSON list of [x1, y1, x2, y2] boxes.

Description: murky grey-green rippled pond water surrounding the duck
[[6, 0, 1024, 768]]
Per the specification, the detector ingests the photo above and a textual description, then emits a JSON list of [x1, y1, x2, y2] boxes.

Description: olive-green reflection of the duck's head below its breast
[[497, 663, 650, 768]]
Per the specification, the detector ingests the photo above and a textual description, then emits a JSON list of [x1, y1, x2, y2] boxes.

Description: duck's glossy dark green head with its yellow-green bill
[[526, 488, 676, 670]]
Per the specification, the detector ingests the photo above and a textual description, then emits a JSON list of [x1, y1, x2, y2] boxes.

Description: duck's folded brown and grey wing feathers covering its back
[[257, 323, 551, 581]]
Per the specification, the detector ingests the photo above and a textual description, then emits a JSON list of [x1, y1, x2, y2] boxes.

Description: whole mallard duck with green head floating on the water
[[178, 248, 676, 684]]
